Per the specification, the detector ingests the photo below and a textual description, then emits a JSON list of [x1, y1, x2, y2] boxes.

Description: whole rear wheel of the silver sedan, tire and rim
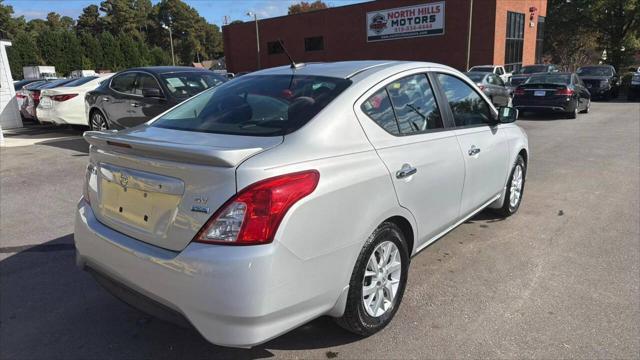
[[336, 222, 410, 336]]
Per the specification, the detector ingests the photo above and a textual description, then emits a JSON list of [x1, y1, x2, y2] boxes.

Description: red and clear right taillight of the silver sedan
[[194, 170, 320, 245]]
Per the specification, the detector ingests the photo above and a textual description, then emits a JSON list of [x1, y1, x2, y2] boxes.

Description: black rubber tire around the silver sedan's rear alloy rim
[[335, 222, 411, 336]]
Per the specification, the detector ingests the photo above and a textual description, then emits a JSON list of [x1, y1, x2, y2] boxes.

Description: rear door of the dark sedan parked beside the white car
[[100, 71, 139, 127]]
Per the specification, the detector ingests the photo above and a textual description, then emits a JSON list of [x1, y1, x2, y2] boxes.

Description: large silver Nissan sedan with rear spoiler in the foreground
[[74, 61, 528, 347]]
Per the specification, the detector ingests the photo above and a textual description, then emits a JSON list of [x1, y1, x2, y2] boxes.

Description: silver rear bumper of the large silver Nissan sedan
[[74, 200, 348, 347]]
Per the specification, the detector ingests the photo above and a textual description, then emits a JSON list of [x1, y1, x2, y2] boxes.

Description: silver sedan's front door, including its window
[[434, 72, 510, 216]]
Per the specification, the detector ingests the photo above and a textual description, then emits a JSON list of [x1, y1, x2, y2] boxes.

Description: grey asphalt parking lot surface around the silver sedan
[[0, 101, 640, 359]]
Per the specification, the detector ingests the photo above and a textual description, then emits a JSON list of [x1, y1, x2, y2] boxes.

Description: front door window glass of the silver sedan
[[438, 74, 491, 126]]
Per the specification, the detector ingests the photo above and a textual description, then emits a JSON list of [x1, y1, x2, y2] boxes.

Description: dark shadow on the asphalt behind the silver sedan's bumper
[[0, 234, 359, 359]]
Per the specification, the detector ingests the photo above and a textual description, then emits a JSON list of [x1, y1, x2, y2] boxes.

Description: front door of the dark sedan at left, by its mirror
[[124, 72, 168, 127]]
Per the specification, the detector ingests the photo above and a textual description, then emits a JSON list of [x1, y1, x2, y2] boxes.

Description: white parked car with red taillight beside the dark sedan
[[37, 74, 113, 128]]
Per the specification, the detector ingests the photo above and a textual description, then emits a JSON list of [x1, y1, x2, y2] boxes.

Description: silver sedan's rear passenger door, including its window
[[354, 72, 464, 247]]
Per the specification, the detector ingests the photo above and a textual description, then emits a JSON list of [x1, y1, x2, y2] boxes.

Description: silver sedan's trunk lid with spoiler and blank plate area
[[84, 126, 283, 251]]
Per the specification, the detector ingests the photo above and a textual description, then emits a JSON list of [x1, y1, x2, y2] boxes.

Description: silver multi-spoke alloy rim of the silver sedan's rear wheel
[[362, 241, 402, 317]]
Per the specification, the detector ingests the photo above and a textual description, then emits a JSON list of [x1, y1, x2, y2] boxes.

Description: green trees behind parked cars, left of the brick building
[[0, 0, 223, 79]]
